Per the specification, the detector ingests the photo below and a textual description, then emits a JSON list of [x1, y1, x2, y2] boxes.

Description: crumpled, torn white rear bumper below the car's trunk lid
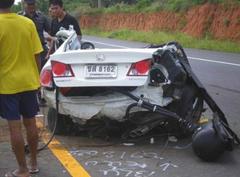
[[43, 86, 172, 123]]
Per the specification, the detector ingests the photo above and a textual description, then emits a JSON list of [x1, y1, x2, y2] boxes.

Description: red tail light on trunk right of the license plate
[[127, 59, 151, 76]]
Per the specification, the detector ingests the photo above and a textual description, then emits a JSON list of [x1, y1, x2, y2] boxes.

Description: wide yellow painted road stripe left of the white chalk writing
[[44, 139, 91, 177]]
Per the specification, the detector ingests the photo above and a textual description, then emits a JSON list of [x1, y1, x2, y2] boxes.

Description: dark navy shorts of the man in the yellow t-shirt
[[0, 91, 39, 120]]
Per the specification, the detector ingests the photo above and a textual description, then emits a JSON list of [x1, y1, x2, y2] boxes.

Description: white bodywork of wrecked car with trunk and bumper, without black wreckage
[[41, 29, 173, 127]]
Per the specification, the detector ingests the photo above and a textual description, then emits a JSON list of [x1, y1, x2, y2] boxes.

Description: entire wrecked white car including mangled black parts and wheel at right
[[41, 31, 239, 161]]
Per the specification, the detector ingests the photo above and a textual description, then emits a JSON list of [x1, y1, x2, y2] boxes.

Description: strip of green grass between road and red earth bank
[[83, 28, 240, 53]]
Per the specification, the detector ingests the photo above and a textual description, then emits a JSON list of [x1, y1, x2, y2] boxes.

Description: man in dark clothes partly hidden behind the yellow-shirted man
[[19, 0, 50, 67]]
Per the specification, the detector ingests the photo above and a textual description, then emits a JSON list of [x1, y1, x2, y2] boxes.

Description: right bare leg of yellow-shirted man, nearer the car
[[23, 118, 38, 170]]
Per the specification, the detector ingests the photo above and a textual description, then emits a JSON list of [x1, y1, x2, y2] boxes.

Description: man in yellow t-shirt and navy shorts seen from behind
[[0, 0, 43, 177]]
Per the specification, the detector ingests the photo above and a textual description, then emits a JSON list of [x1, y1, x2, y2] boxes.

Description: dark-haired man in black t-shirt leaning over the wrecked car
[[47, 0, 82, 58]]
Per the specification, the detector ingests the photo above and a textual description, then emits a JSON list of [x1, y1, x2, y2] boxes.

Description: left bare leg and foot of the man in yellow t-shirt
[[8, 120, 29, 177]]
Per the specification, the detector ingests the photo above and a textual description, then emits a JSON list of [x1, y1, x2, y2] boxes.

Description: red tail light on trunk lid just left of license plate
[[51, 61, 74, 77]]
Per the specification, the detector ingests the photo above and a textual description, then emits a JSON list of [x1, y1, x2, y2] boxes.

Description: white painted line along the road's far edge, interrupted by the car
[[88, 40, 240, 67]]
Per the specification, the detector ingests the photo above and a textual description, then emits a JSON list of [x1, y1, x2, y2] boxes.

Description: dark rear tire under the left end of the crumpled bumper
[[47, 108, 73, 135]]
